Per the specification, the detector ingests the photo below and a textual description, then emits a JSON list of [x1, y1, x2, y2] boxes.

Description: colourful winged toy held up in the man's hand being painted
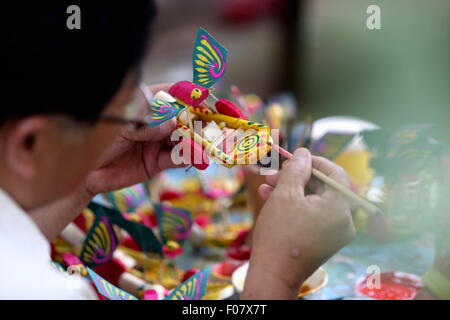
[[148, 29, 271, 170]]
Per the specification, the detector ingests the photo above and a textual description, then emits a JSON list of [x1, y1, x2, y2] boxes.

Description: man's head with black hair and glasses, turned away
[[0, 0, 155, 209]]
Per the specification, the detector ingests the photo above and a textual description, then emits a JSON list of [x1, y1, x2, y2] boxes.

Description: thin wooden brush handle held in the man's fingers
[[272, 144, 382, 215]]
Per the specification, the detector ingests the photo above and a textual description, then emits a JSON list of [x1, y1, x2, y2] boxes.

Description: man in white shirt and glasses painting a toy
[[0, 0, 354, 299]]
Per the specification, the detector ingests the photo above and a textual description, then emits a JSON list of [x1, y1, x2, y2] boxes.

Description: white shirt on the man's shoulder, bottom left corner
[[0, 189, 97, 300]]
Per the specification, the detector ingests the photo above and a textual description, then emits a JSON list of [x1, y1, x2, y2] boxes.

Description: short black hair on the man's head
[[0, 0, 156, 124]]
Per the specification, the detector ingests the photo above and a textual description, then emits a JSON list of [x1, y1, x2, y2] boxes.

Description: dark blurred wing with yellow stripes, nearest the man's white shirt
[[80, 216, 117, 268]]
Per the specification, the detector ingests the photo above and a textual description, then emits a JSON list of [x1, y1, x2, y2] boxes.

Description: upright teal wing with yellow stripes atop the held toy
[[192, 28, 228, 88]]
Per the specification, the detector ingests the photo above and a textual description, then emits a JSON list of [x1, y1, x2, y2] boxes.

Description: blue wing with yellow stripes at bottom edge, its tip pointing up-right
[[164, 267, 211, 300]]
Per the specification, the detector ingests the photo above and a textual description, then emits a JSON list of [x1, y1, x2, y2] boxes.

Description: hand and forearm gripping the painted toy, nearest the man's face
[[30, 84, 183, 240]]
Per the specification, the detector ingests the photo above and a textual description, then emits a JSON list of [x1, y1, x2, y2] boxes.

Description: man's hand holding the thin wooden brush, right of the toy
[[243, 149, 355, 299]]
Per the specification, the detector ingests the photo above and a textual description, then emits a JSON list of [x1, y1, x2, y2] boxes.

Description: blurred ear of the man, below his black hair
[[3, 116, 50, 180]]
